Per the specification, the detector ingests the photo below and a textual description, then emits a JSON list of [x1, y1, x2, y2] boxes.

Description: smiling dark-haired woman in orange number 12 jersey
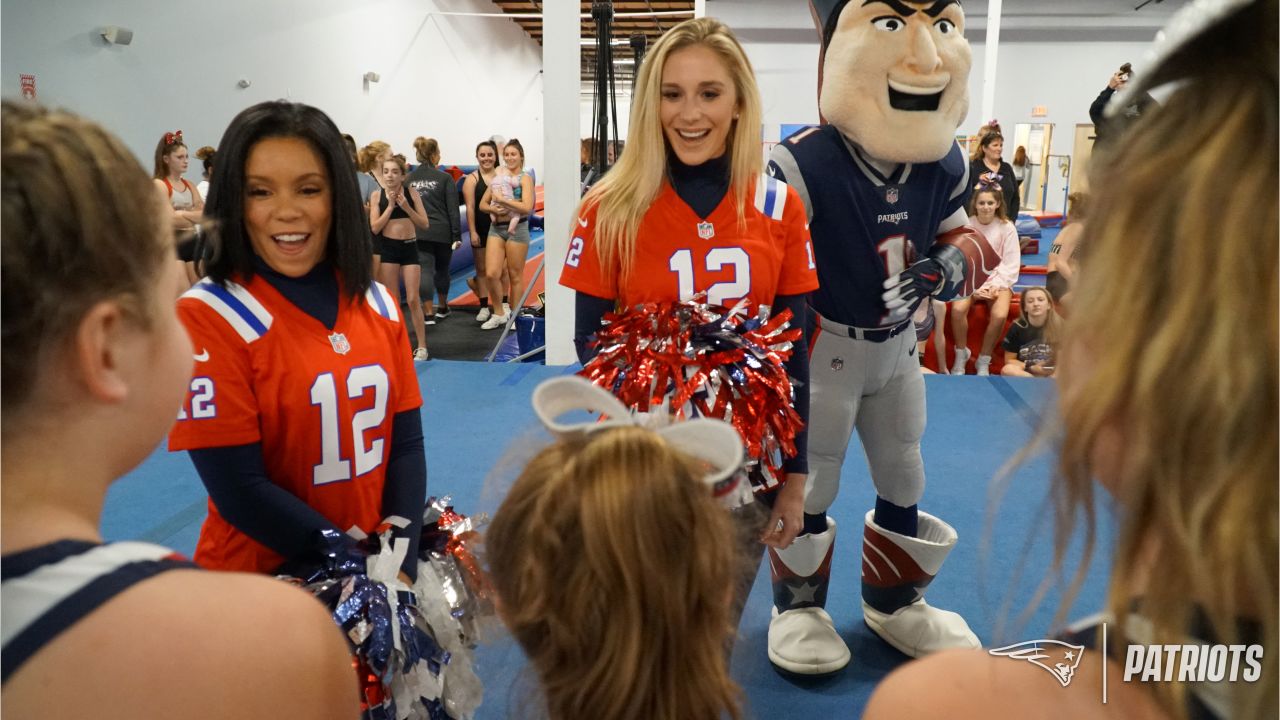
[[169, 102, 426, 594]]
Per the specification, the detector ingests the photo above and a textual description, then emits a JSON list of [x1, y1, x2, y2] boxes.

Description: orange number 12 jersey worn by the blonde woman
[[559, 174, 818, 313]]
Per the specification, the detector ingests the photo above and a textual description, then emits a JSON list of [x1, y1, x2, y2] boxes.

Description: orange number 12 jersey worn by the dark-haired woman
[[169, 275, 422, 573]]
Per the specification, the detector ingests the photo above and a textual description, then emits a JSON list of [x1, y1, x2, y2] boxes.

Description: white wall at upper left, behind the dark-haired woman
[[0, 0, 543, 178]]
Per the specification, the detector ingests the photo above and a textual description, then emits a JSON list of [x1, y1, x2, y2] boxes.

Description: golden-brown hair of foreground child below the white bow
[[485, 428, 740, 720]]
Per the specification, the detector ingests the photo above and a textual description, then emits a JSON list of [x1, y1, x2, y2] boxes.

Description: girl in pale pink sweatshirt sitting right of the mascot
[[951, 184, 1021, 375]]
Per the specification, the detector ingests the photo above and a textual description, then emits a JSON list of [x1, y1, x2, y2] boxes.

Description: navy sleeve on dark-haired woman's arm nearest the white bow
[[383, 409, 426, 580]]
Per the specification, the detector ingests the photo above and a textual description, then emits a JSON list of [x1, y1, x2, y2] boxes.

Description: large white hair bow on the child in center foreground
[[532, 375, 745, 488]]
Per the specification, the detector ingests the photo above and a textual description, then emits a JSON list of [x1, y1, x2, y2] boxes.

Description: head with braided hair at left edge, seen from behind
[[0, 101, 191, 456]]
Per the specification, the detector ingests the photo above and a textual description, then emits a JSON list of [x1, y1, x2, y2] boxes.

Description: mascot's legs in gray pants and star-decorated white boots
[[769, 312, 979, 675]]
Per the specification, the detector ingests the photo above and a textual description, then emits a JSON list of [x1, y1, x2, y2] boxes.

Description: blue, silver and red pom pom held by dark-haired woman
[[278, 498, 495, 720]]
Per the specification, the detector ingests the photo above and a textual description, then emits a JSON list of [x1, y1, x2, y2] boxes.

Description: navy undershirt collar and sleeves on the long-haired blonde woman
[[573, 154, 809, 473]]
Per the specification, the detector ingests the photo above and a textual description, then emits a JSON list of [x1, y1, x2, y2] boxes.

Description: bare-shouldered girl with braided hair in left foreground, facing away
[[0, 101, 358, 720]]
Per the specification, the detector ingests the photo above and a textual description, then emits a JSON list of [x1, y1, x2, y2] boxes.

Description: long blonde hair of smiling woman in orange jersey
[[579, 18, 763, 278]]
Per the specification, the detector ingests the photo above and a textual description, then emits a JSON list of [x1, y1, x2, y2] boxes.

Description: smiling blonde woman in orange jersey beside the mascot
[[561, 12, 818, 661]]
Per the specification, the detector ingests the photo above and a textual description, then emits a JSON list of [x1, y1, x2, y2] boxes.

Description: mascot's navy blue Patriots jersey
[[769, 126, 970, 328]]
